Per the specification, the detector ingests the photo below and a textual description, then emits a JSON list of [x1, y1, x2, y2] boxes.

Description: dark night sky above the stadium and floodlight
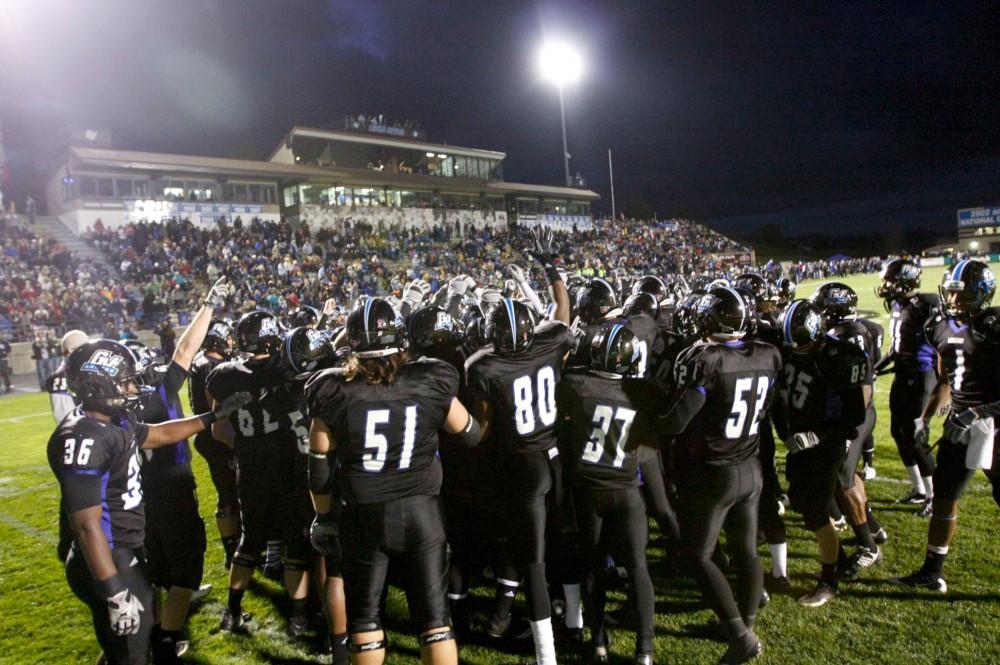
[[0, 0, 1000, 234]]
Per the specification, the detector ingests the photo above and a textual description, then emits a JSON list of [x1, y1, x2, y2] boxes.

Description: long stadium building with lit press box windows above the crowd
[[45, 125, 600, 234]]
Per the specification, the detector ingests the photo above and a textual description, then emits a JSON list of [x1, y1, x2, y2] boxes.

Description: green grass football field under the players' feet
[[0, 269, 1000, 665]]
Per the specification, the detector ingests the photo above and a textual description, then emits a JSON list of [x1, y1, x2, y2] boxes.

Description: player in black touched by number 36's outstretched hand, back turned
[[208, 311, 312, 635]]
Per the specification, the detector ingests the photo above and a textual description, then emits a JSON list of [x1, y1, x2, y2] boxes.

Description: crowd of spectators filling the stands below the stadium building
[[0, 211, 892, 341]]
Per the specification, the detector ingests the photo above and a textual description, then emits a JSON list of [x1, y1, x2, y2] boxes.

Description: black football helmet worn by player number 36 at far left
[[66, 339, 152, 417]]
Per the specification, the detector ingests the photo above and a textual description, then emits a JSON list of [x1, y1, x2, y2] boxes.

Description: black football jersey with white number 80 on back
[[466, 321, 574, 453]]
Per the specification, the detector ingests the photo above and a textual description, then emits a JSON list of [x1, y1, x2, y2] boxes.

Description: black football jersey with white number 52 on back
[[677, 340, 782, 465]]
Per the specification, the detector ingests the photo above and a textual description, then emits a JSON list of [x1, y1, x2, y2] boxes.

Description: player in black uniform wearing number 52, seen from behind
[[664, 286, 782, 663]]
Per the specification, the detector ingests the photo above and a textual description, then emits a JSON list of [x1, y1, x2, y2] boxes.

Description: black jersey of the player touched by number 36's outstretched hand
[[208, 358, 309, 455]]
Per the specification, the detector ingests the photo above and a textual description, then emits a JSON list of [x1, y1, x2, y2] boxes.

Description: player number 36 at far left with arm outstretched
[[48, 340, 249, 665]]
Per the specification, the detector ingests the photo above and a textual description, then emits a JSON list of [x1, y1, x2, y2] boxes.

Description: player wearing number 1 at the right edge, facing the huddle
[[894, 259, 1000, 593]]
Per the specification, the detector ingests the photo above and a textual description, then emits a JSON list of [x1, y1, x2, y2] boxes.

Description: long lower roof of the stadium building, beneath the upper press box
[[69, 146, 601, 201]]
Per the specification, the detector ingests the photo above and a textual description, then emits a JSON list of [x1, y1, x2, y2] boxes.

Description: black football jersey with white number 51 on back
[[305, 358, 459, 504]]
